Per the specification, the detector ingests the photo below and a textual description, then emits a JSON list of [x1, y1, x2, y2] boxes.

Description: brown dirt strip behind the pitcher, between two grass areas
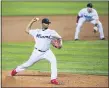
[[2, 16, 108, 42]]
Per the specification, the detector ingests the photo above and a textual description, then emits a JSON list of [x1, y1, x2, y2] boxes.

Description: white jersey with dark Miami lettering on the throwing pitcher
[[29, 29, 61, 51]]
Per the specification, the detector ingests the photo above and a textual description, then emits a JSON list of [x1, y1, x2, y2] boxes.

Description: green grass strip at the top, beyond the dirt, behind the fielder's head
[[2, 1, 108, 16]]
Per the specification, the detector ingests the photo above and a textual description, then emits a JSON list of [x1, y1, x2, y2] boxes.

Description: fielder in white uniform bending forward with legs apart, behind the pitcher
[[74, 3, 105, 40]]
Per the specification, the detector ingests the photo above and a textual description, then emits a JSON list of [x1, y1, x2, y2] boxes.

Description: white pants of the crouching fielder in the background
[[75, 18, 104, 39]]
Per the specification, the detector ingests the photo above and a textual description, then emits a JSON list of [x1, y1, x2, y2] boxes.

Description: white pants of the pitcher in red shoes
[[16, 49, 57, 80]]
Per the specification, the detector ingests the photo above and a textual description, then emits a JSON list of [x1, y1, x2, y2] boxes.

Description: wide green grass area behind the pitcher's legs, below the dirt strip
[[2, 41, 108, 75]]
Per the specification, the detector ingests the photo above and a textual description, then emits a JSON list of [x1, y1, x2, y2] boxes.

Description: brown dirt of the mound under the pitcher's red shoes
[[2, 71, 108, 88]]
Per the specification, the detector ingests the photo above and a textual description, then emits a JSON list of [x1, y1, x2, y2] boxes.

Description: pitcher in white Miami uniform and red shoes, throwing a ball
[[11, 18, 62, 84]]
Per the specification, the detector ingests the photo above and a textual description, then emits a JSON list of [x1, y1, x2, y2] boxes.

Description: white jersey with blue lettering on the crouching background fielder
[[78, 8, 99, 21]]
